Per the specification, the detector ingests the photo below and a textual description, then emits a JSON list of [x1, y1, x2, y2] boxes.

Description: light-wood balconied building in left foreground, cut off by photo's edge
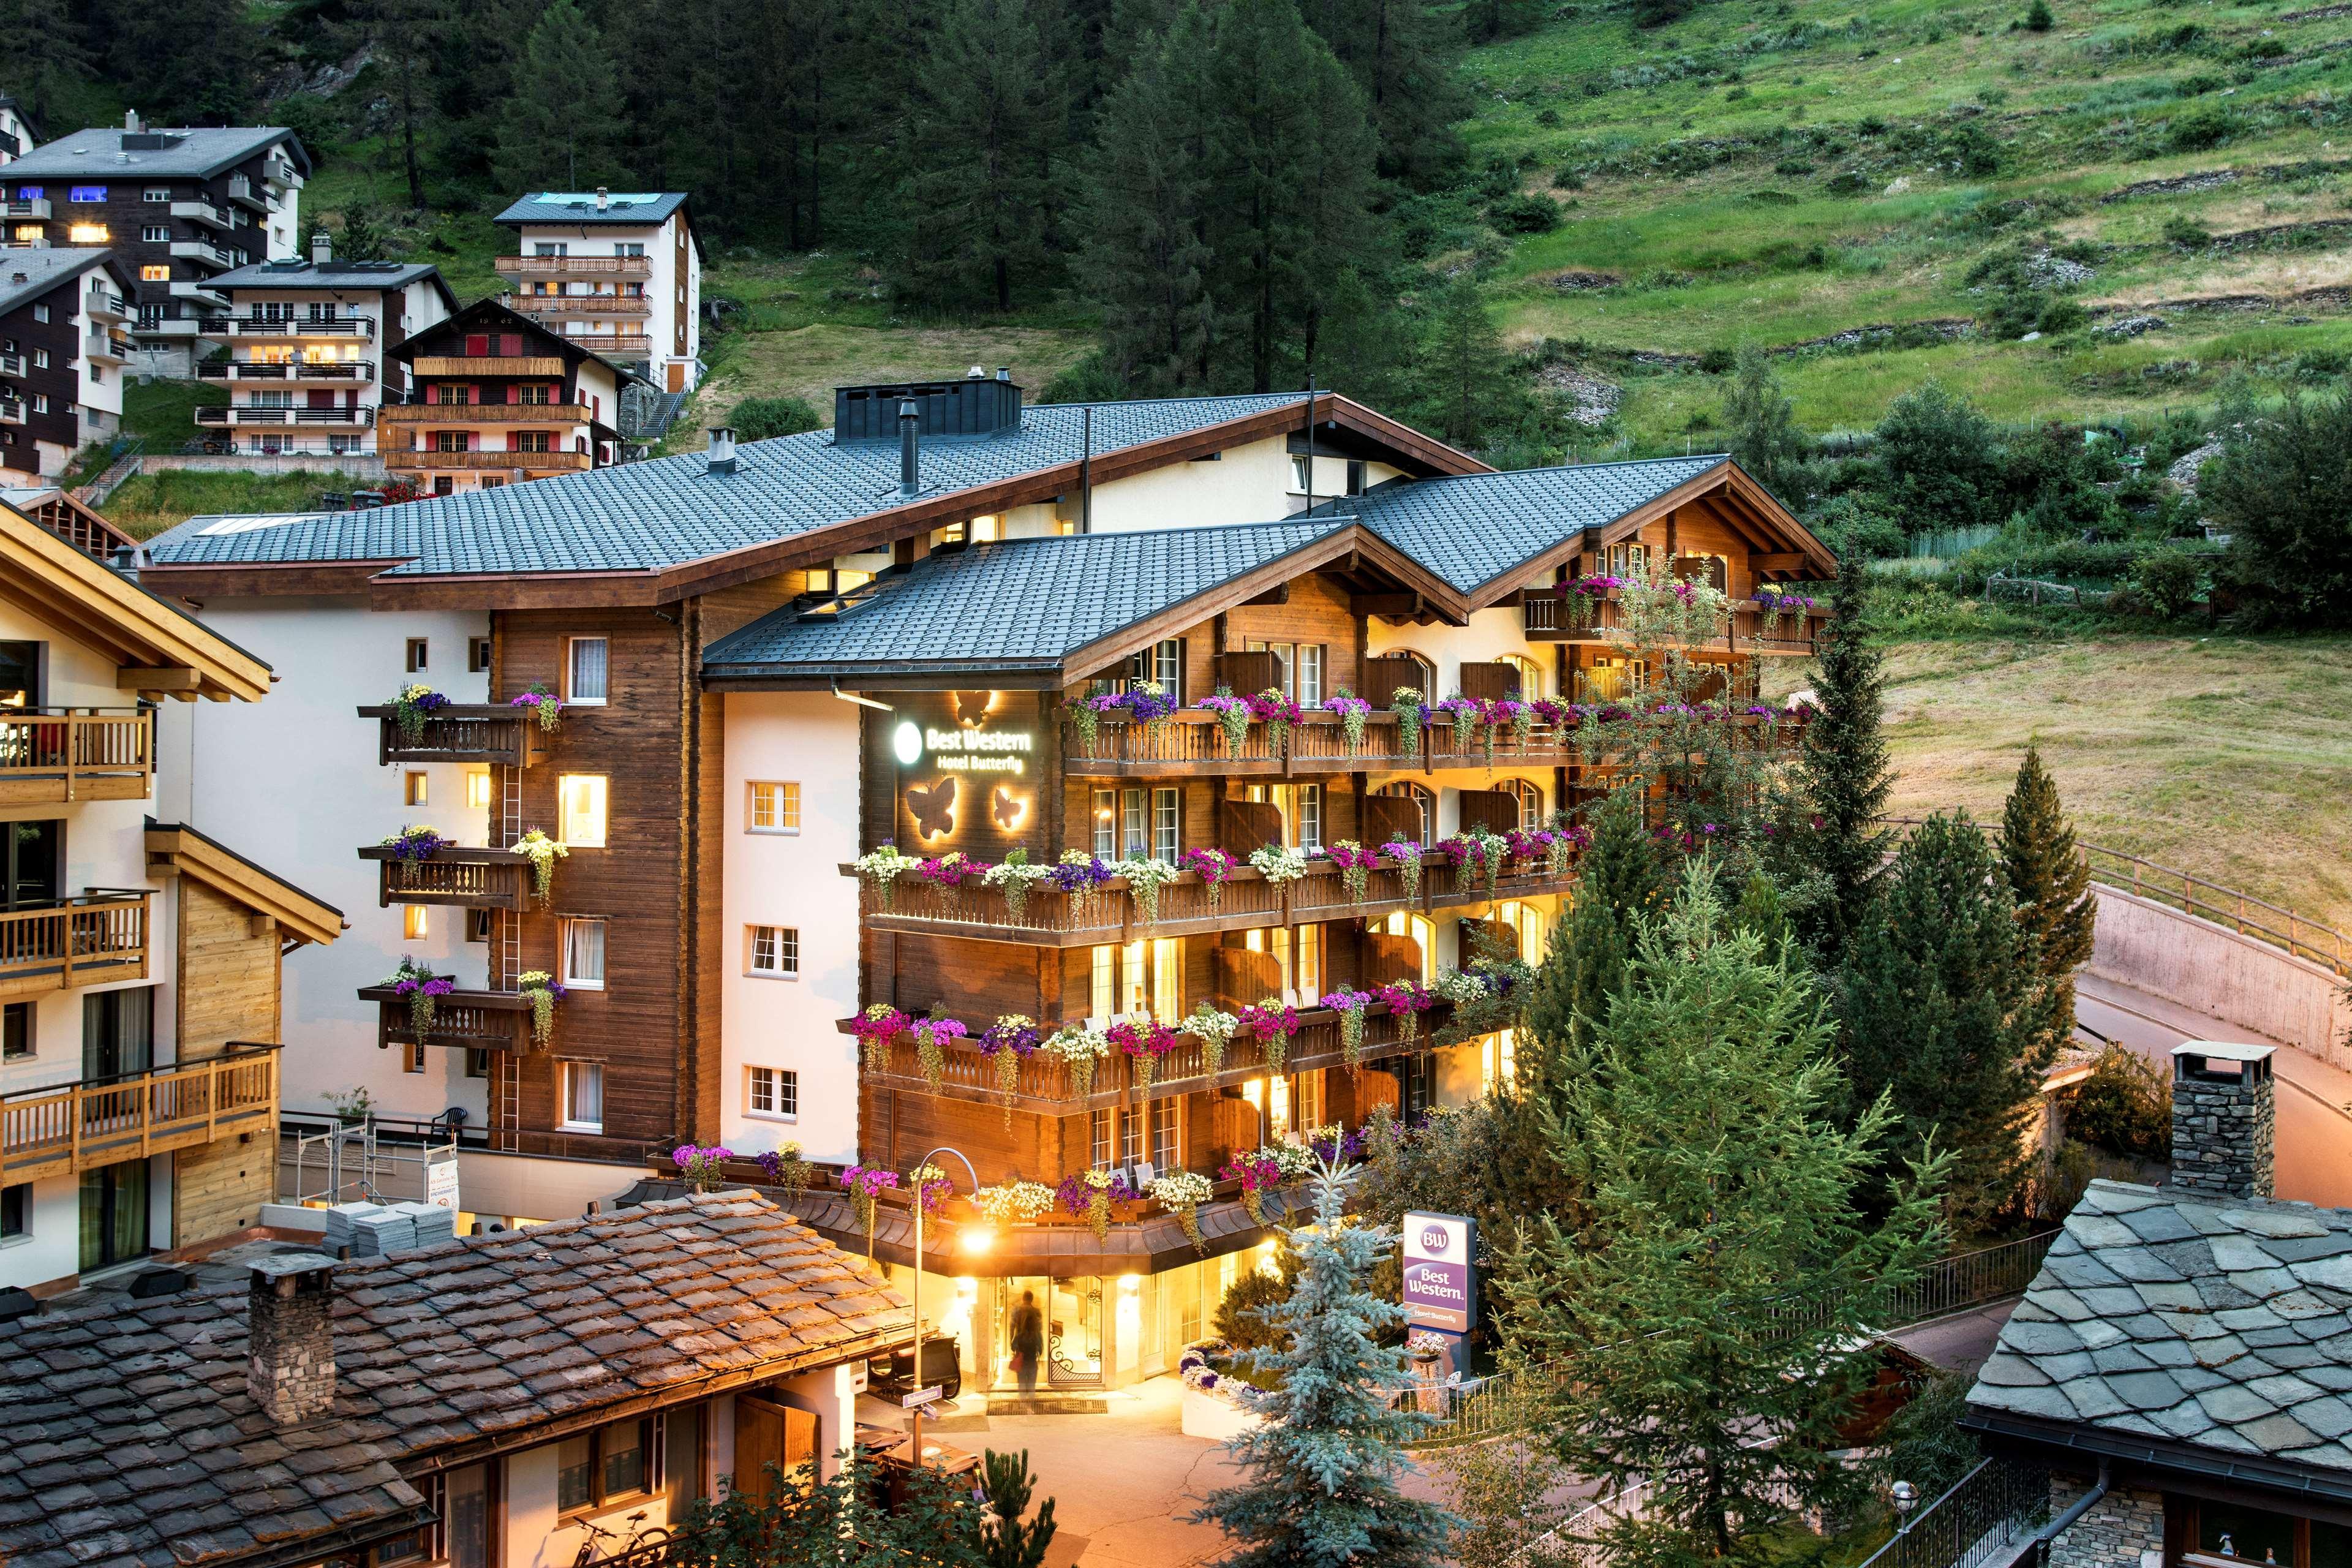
[[0, 505, 341, 1295]]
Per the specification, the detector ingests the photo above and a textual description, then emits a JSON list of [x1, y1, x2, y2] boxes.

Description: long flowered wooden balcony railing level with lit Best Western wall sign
[[1063, 705, 1804, 778]]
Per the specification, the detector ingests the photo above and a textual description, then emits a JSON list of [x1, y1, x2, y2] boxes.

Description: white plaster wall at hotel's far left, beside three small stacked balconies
[[157, 597, 491, 1128]]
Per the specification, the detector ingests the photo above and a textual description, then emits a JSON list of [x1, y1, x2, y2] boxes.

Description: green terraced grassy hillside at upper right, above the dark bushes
[[1468, 0, 2352, 447]]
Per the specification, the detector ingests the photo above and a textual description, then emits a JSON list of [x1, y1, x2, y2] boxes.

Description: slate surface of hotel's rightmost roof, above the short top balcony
[[1315, 456, 1727, 592]]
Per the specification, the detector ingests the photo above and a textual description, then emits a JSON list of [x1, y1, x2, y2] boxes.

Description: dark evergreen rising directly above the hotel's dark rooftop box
[[901, 0, 1068, 311]]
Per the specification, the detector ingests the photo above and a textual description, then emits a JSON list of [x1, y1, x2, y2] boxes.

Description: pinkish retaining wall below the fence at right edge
[[2089, 884, 2352, 1069]]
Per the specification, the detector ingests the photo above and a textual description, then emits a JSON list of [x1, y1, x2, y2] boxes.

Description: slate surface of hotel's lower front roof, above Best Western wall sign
[[703, 517, 1348, 675]]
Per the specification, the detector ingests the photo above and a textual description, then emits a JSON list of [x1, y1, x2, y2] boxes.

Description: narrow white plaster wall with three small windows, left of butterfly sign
[[720, 691, 859, 1161]]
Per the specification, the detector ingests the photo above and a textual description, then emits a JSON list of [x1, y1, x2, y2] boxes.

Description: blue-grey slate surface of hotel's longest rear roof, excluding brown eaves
[[151, 393, 1305, 576]]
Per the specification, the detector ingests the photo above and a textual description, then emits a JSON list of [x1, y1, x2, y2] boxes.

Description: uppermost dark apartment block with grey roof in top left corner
[[0, 113, 311, 376]]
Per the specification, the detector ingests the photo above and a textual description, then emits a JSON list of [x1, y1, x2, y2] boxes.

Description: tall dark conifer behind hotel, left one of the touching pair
[[1077, 0, 1216, 393]]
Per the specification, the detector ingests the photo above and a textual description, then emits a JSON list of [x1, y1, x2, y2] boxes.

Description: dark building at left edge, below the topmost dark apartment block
[[0, 247, 132, 484]]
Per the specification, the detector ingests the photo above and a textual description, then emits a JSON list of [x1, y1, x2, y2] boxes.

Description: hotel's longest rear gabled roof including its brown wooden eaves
[[137, 393, 1479, 606]]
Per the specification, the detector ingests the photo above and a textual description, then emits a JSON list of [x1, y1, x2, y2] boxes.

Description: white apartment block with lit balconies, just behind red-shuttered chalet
[[195, 233, 456, 454]]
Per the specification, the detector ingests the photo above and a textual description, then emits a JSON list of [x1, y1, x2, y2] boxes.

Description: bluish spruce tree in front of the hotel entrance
[[1188, 1166, 1453, 1568]]
